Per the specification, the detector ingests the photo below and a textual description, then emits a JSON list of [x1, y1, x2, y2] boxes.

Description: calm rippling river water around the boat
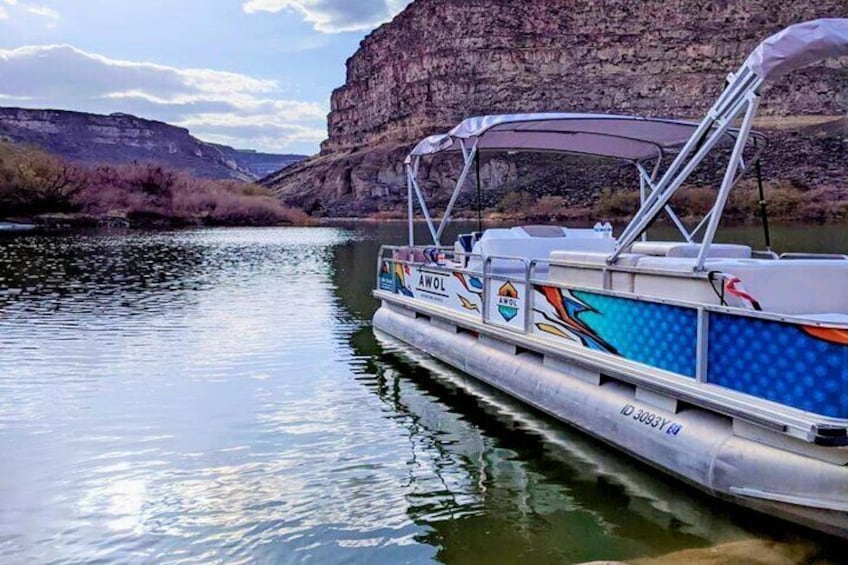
[[0, 225, 848, 563]]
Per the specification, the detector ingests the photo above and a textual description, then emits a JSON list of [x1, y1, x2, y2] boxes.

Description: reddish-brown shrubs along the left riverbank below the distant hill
[[0, 143, 308, 226]]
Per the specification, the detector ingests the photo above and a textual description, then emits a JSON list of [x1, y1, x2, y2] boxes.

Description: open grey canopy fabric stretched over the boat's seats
[[407, 113, 748, 163]]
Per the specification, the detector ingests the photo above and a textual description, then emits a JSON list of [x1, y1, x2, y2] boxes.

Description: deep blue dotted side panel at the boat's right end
[[707, 314, 848, 418]]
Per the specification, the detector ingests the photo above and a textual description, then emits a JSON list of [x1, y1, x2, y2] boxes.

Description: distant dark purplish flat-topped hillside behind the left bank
[[0, 108, 304, 180]]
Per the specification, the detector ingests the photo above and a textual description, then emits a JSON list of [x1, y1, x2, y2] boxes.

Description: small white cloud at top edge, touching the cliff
[[242, 0, 411, 33]]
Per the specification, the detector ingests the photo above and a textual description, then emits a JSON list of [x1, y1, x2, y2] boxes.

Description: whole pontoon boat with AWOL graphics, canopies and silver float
[[374, 19, 848, 537]]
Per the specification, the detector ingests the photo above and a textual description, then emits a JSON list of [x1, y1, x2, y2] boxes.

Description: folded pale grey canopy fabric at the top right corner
[[745, 18, 848, 80]]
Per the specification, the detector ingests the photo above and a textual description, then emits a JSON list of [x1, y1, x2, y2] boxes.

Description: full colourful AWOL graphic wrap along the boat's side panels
[[380, 261, 848, 418]]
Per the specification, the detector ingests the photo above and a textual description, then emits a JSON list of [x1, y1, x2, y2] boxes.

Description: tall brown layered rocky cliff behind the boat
[[264, 0, 848, 214]]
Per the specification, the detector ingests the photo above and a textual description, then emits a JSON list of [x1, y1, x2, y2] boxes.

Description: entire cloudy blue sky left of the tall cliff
[[0, 0, 409, 154]]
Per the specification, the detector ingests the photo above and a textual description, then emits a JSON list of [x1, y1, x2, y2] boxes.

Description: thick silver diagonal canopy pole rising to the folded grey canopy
[[607, 68, 763, 263]]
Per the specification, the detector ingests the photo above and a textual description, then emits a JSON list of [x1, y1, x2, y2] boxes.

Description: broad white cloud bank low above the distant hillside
[[0, 45, 327, 152]]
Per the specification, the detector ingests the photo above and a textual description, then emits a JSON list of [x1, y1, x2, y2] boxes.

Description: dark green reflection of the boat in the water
[[354, 324, 749, 562]]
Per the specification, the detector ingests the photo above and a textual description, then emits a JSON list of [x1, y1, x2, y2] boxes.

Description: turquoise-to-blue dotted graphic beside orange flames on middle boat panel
[[572, 291, 698, 378]]
